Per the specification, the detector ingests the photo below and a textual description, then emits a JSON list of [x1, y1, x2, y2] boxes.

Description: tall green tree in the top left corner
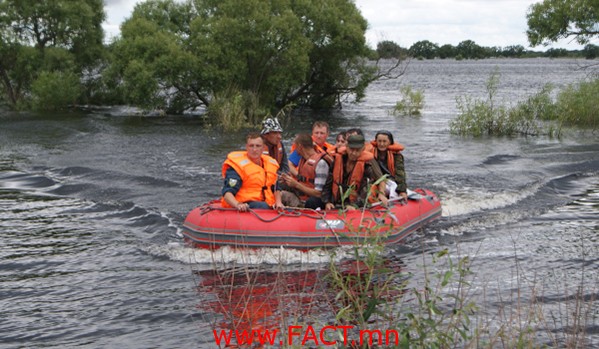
[[0, 0, 105, 108]]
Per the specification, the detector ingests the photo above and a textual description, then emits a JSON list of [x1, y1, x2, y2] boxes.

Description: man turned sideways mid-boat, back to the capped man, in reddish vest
[[281, 133, 333, 209]]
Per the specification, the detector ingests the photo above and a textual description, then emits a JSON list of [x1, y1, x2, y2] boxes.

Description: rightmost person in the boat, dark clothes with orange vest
[[371, 131, 408, 199]]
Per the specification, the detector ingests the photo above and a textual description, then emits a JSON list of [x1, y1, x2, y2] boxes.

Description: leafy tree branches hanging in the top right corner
[[526, 0, 599, 46]]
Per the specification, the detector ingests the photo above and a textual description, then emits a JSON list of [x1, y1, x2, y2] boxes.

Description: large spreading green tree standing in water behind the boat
[[110, 0, 406, 113]]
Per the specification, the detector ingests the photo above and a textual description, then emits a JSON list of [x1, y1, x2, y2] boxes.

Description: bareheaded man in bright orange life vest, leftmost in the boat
[[221, 132, 284, 212]]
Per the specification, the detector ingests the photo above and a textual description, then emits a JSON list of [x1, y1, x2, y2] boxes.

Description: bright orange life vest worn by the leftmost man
[[221, 151, 279, 207]]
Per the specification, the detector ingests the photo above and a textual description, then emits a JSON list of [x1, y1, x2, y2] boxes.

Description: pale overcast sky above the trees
[[104, 0, 581, 50]]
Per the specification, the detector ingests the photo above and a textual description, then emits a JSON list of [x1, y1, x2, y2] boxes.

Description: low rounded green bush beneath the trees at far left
[[31, 71, 81, 111]]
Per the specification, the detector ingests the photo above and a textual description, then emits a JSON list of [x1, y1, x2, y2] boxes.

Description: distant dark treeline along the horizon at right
[[376, 40, 599, 60]]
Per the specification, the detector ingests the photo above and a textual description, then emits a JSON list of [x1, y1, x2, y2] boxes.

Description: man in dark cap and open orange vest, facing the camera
[[322, 134, 388, 210]]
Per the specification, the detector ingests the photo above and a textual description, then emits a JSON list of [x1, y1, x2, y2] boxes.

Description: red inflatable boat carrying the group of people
[[183, 189, 441, 250]]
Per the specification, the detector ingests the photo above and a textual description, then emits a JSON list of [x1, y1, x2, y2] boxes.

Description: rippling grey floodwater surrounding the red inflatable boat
[[0, 59, 599, 348]]
